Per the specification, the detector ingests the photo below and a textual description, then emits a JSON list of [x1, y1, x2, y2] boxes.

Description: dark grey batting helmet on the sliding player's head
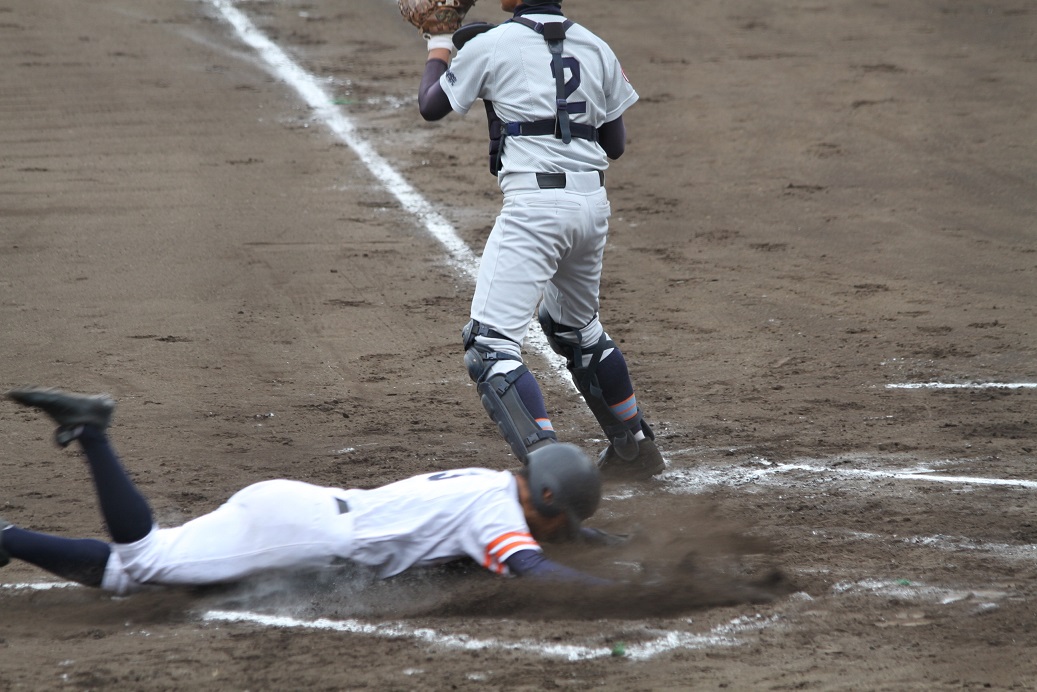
[[526, 442, 601, 533]]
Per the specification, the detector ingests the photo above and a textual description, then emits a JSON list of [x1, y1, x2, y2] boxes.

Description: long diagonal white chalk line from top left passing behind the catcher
[[209, 0, 576, 379]]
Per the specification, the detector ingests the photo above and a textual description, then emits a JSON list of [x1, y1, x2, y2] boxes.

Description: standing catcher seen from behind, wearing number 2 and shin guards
[[404, 0, 666, 479]]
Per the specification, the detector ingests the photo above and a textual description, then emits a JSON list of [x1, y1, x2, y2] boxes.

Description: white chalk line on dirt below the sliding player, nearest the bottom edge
[[202, 610, 781, 661]]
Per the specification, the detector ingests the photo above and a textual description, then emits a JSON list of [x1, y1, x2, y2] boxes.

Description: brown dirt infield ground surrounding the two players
[[0, 0, 1037, 690]]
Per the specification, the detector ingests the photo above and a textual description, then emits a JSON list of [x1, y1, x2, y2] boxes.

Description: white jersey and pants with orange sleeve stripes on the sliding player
[[102, 469, 541, 593]]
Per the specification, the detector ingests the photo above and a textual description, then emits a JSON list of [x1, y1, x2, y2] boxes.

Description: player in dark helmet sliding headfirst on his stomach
[[0, 388, 612, 593]]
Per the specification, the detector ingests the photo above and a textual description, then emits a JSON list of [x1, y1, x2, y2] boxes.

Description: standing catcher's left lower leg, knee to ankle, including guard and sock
[[461, 320, 558, 464]]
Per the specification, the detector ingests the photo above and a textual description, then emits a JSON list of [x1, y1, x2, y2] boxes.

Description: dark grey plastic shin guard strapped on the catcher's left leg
[[465, 323, 558, 464]]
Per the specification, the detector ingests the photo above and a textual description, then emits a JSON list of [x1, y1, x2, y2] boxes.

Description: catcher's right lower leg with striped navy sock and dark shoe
[[538, 303, 666, 477]]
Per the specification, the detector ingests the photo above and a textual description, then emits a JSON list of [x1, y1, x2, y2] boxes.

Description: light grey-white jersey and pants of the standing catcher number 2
[[440, 13, 638, 346]]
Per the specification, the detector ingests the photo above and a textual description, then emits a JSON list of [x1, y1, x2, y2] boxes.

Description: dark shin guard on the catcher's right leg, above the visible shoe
[[537, 303, 642, 462]]
